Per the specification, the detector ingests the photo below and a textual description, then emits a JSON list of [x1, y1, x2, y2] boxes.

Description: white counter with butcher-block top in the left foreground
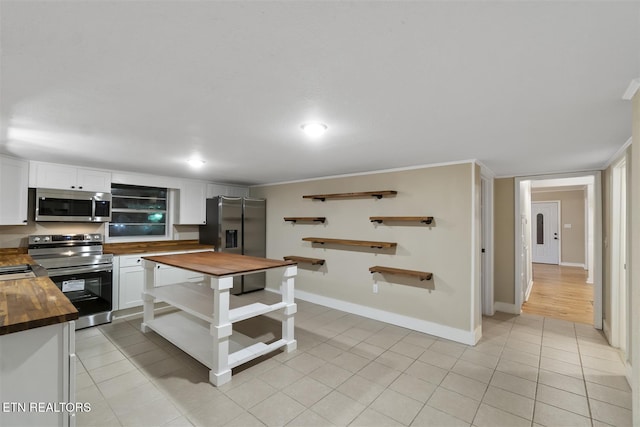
[[0, 254, 78, 426]]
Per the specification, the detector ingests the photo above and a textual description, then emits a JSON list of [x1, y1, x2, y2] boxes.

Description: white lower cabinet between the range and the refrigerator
[[118, 251, 204, 310]]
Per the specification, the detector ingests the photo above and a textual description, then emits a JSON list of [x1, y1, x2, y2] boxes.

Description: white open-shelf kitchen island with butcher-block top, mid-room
[[142, 252, 297, 386]]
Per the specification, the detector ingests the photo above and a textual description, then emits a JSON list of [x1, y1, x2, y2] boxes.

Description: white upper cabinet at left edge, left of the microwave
[[0, 156, 29, 225]]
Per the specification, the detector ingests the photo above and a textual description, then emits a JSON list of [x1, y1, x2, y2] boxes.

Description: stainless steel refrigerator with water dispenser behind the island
[[200, 196, 267, 295]]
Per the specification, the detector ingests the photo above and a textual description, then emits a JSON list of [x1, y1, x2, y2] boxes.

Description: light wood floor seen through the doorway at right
[[522, 264, 593, 324]]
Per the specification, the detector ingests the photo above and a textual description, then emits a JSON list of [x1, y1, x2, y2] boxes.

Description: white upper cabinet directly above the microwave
[[29, 162, 111, 193]]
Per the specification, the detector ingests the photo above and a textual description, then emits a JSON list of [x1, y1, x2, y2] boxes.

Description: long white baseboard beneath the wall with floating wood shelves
[[266, 288, 482, 345]]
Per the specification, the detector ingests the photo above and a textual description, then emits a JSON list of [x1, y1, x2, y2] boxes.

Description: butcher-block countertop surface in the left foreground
[[0, 278, 78, 335]]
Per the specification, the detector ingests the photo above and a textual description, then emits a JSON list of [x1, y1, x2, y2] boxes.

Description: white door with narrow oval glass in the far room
[[531, 202, 560, 264]]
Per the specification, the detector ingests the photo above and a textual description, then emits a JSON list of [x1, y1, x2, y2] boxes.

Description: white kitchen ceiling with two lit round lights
[[0, 0, 640, 183]]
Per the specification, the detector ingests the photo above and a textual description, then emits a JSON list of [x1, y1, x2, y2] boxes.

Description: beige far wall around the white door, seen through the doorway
[[531, 190, 586, 264]]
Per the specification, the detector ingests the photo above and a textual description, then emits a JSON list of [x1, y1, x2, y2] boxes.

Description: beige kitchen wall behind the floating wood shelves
[[251, 163, 477, 340]]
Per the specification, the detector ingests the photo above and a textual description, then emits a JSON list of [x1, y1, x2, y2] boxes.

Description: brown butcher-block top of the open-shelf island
[[143, 252, 295, 276]]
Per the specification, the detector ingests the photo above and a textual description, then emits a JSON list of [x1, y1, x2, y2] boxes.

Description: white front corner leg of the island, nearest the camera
[[209, 277, 233, 386]]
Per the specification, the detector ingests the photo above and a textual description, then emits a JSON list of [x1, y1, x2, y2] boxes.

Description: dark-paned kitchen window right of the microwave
[[109, 184, 168, 237]]
